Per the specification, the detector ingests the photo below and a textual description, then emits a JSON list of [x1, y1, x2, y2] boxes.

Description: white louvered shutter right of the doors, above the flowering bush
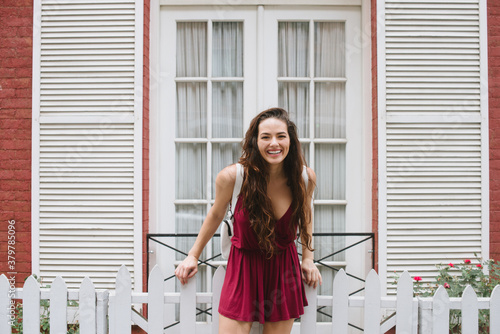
[[378, 0, 488, 292]]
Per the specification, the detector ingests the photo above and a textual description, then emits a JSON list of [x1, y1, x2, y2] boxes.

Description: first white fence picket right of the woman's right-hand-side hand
[[332, 269, 349, 334]]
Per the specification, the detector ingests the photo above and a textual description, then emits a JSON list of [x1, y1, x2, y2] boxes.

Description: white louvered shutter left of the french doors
[[32, 0, 142, 288]]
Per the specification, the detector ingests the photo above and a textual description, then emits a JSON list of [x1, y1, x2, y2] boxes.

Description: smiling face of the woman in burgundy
[[257, 118, 290, 164]]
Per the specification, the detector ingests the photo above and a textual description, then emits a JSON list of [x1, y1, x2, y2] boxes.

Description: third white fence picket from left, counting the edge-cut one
[[50, 276, 68, 334]]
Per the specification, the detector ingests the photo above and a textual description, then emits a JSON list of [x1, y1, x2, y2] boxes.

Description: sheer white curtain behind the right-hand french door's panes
[[278, 22, 346, 302]]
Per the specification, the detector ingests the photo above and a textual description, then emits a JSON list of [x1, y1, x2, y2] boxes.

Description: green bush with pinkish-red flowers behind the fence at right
[[395, 258, 500, 334]]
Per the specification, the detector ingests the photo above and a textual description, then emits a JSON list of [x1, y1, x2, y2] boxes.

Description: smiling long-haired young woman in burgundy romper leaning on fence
[[175, 108, 322, 334]]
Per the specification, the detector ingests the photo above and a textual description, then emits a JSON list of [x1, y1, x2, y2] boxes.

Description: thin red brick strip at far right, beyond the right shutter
[[488, 0, 500, 260]]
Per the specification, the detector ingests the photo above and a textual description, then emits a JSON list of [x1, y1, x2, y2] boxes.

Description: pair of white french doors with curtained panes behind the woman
[[155, 6, 371, 322]]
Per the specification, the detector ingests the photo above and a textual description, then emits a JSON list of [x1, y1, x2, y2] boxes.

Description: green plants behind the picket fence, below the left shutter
[[11, 275, 80, 334]]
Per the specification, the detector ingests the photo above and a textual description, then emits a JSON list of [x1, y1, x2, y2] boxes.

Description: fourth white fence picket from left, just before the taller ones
[[78, 277, 97, 334]]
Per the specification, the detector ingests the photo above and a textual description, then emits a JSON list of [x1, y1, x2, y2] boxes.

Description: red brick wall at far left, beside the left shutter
[[0, 0, 33, 286]]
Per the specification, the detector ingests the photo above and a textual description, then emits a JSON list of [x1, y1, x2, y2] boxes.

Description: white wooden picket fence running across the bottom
[[0, 266, 500, 334]]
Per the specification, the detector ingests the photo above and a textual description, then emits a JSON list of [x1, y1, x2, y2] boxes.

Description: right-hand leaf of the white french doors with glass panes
[[261, 7, 369, 308]]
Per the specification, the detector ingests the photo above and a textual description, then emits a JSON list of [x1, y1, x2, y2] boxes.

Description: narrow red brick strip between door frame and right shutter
[[371, 0, 378, 271]]
